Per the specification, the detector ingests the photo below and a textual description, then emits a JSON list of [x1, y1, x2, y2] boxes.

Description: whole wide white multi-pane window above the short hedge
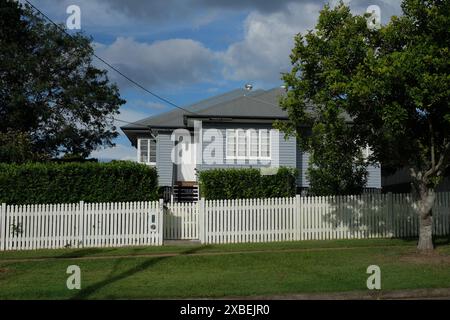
[[226, 129, 270, 159]]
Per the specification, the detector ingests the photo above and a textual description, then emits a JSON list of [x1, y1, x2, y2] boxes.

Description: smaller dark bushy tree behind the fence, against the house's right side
[[307, 120, 367, 196]]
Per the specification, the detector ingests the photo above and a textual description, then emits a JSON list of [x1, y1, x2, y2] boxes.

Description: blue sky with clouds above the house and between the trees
[[22, 0, 401, 161]]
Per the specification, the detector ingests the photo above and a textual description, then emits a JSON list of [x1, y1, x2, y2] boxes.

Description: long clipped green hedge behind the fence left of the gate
[[0, 161, 158, 204]]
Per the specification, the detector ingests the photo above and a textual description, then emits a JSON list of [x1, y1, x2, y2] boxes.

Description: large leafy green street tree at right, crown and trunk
[[281, 0, 450, 251]]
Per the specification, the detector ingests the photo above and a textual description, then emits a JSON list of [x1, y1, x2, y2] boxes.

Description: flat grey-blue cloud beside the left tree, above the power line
[[95, 37, 216, 88]]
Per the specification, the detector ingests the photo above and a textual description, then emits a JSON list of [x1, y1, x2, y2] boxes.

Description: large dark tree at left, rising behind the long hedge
[[0, 0, 125, 157]]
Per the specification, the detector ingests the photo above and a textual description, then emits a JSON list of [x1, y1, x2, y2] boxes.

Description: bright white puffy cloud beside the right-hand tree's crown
[[222, 3, 322, 82]]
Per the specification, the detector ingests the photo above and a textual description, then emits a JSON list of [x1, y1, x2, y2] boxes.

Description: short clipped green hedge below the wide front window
[[199, 168, 297, 200]]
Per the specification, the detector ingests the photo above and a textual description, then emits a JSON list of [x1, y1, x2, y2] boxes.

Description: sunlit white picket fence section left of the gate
[[0, 202, 163, 250]]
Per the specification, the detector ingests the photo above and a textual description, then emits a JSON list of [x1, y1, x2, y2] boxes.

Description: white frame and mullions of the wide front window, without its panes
[[225, 128, 272, 160]]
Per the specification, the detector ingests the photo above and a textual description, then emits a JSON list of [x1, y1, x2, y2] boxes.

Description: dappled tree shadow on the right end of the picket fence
[[316, 194, 450, 238]]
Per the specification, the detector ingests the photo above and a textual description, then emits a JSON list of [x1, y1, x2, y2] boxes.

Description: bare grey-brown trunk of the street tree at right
[[416, 183, 436, 253]]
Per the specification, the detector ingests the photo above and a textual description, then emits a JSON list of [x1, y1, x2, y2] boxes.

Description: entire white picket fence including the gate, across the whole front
[[0, 192, 450, 250]]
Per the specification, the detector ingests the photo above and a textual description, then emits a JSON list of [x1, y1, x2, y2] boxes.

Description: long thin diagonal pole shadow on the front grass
[[70, 246, 208, 300]]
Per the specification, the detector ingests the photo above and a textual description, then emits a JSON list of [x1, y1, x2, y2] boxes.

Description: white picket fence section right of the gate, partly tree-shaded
[[199, 193, 450, 243]]
